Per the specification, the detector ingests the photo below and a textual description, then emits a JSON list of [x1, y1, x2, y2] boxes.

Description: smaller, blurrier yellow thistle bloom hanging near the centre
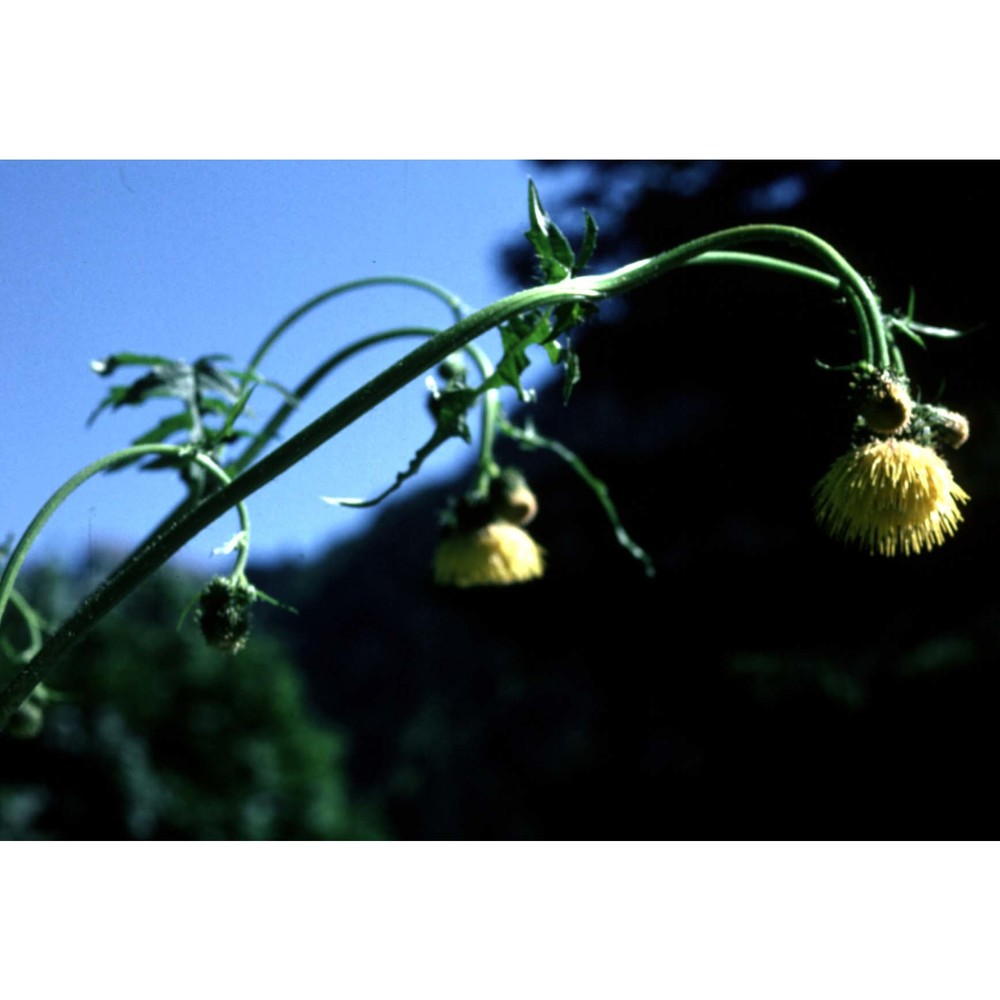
[[434, 521, 545, 587]]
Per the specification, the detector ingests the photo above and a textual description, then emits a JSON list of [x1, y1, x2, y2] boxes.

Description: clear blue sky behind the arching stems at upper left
[[0, 161, 580, 570]]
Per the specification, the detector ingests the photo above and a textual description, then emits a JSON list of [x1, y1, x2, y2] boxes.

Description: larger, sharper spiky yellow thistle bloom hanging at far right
[[816, 438, 969, 556]]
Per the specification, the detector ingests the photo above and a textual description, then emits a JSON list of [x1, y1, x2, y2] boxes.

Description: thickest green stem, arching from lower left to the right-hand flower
[[0, 225, 889, 727]]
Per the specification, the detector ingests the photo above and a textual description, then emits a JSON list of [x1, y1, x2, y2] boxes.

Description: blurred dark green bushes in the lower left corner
[[0, 566, 381, 840]]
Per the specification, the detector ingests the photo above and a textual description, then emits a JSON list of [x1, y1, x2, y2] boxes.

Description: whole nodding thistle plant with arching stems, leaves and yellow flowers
[[0, 183, 968, 734]]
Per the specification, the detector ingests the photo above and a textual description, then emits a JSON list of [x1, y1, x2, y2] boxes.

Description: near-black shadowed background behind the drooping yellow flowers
[[0, 162, 1000, 839]]
